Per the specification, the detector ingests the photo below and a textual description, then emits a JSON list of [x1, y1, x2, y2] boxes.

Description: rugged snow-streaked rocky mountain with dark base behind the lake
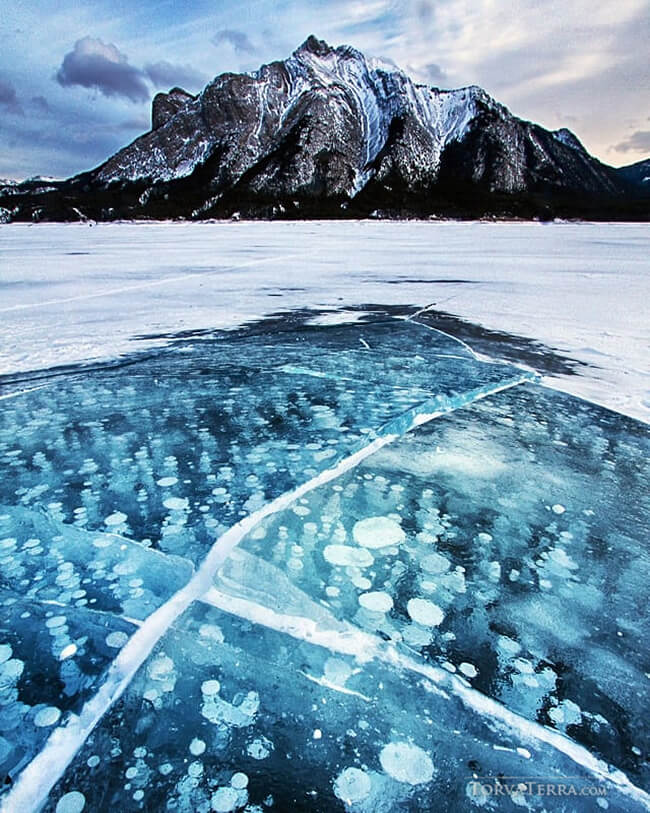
[[0, 37, 648, 220]]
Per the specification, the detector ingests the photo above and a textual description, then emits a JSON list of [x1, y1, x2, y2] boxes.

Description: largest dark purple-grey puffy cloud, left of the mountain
[[56, 37, 151, 102]]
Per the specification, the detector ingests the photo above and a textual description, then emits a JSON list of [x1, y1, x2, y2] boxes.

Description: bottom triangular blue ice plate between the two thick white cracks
[[44, 606, 643, 813]]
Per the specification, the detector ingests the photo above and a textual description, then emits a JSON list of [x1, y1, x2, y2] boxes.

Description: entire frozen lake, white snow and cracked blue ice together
[[0, 223, 650, 813]]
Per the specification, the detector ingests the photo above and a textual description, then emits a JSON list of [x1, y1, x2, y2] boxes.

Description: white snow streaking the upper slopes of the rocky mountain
[[97, 38, 492, 193]]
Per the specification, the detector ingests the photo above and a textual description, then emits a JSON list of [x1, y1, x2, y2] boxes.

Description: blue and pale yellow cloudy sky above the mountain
[[0, 0, 650, 179]]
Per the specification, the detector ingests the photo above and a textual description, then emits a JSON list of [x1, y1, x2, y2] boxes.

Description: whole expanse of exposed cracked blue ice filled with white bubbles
[[0, 272, 650, 813]]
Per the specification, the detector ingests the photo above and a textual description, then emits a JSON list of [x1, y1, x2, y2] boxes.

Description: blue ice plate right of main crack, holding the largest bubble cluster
[[225, 387, 650, 787]]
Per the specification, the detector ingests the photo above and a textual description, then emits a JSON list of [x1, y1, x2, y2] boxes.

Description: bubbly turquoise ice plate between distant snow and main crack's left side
[[0, 320, 525, 560]]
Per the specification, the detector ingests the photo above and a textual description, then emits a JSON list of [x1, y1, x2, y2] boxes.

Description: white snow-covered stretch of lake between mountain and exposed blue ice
[[0, 221, 650, 421]]
